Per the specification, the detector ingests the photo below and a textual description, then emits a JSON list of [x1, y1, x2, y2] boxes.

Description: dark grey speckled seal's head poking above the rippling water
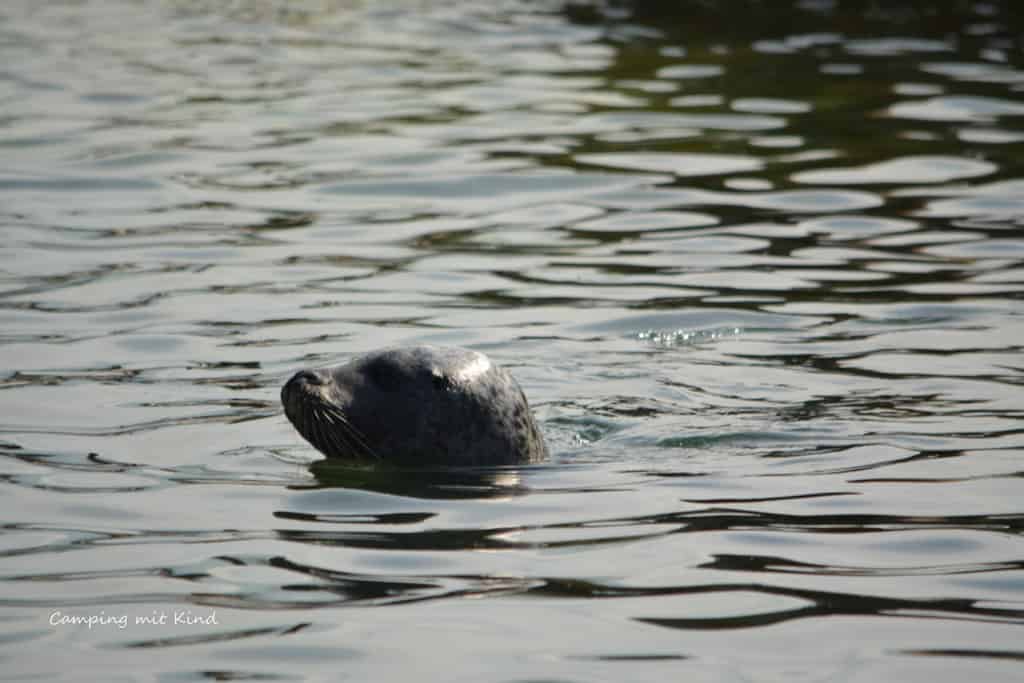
[[281, 346, 548, 467]]
